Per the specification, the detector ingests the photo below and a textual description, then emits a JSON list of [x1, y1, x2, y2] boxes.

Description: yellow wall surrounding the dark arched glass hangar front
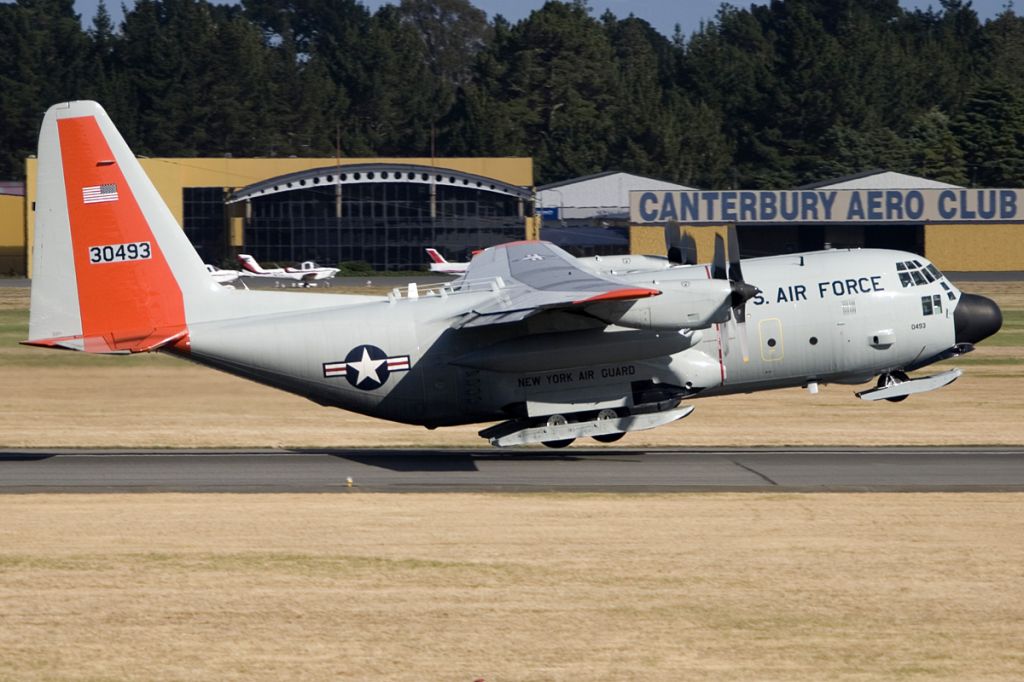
[[24, 157, 534, 276]]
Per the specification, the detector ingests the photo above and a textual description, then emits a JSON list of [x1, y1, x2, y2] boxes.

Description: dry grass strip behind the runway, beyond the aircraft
[[0, 282, 1024, 447]]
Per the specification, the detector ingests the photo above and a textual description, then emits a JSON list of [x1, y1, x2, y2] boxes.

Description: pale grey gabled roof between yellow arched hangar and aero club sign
[[537, 171, 693, 217]]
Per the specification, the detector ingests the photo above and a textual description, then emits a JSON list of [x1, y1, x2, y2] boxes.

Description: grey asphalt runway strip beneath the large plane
[[0, 447, 1024, 494]]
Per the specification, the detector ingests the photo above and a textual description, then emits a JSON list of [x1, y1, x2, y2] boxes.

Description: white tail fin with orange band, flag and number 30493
[[29, 101, 222, 352]]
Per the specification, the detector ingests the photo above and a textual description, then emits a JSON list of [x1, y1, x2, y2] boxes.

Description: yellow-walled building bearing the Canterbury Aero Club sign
[[630, 171, 1024, 271]]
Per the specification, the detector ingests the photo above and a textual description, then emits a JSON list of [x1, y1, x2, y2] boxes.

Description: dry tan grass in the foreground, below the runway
[[0, 494, 1024, 682]]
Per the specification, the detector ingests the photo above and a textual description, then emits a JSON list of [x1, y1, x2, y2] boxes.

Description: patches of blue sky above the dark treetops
[[75, 0, 1007, 37]]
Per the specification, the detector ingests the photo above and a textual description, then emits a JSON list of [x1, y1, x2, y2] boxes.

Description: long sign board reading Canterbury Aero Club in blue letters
[[630, 188, 1024, 224]]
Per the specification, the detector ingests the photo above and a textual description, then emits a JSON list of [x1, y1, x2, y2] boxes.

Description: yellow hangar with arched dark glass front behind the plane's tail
[[18, 153, 538, 275]]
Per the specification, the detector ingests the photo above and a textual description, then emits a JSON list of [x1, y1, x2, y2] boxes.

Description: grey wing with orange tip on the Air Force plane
[[455, 242, 662, 329]]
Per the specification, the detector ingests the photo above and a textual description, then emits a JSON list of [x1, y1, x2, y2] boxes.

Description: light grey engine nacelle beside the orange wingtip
[[587, 280, 733, 331]]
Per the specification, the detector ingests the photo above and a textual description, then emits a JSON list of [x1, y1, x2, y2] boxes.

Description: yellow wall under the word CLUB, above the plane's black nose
[[925, 224, 1024, 271]]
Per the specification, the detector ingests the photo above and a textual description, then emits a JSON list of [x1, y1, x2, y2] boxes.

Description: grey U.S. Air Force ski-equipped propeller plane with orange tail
[[26, 101, 1002, 446]]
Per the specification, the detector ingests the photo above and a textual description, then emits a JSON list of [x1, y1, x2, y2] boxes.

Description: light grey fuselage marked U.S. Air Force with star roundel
[[178, 250, 961, 427]]
